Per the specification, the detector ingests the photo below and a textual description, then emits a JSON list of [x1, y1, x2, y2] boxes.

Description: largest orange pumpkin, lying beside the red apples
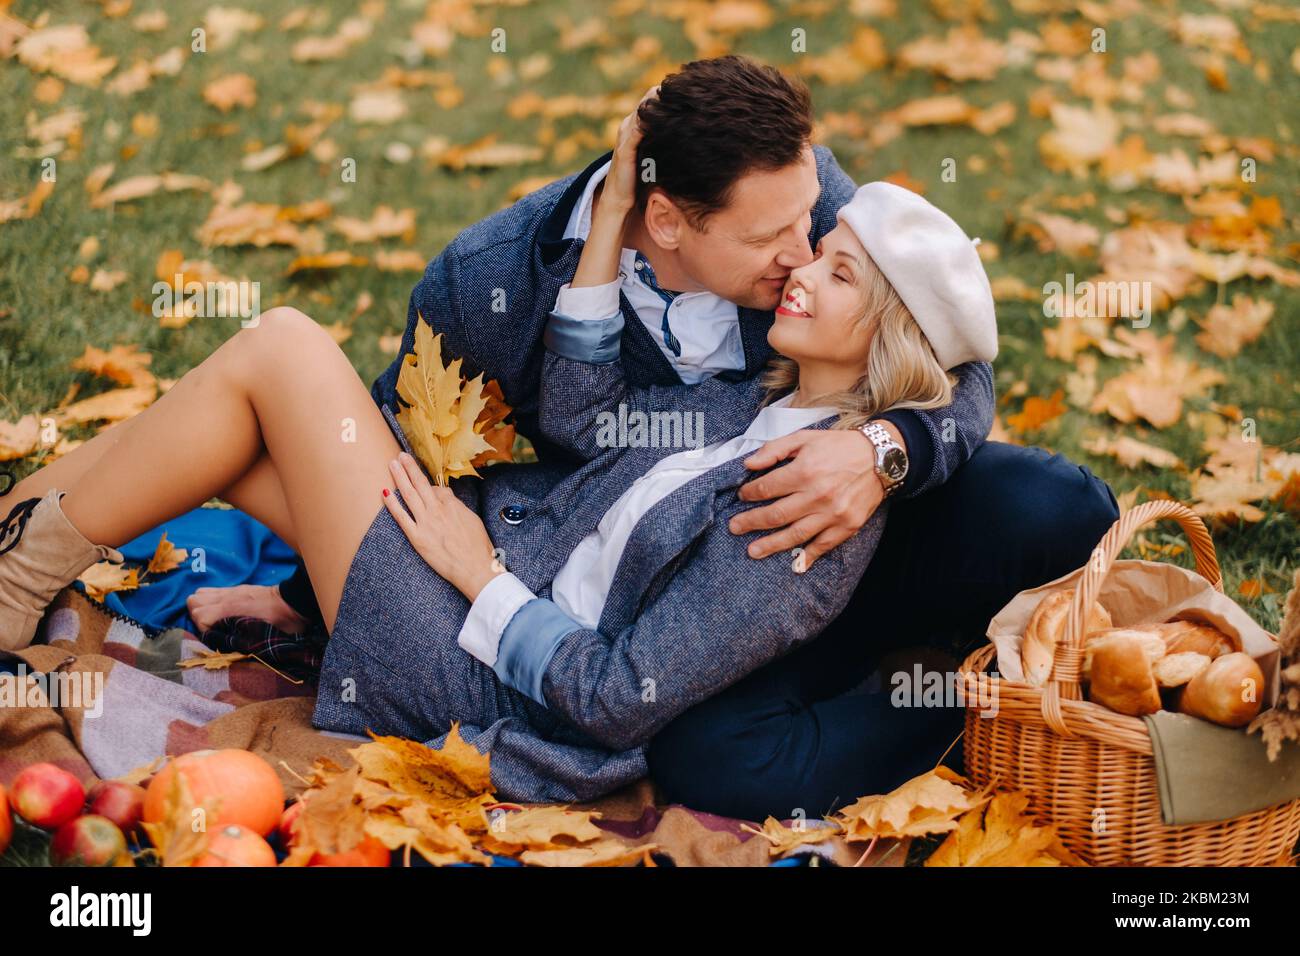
[[144, 749, 285, 836]]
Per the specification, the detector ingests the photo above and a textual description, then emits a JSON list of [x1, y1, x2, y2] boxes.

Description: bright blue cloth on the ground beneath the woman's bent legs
[[104, 507, 296, 632]]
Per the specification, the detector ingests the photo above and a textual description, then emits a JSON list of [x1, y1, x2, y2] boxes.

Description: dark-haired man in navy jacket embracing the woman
[[191, 56, 1115, 819]]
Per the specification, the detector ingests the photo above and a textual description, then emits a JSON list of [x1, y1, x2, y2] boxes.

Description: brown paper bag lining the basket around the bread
[[988, 561, 1282, 710]]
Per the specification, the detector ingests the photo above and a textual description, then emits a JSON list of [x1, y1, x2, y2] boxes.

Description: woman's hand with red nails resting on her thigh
[[384, 451, 504, 601]]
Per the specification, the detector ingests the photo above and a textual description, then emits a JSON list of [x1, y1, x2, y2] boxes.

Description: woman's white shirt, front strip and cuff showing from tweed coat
[[456, 393, 836, 667]]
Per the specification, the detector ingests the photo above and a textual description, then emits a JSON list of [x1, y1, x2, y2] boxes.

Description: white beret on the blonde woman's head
[[836, 182, 997, 368]]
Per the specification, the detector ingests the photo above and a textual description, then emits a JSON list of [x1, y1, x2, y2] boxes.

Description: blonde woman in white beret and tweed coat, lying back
[[0, 138, 996, 800]]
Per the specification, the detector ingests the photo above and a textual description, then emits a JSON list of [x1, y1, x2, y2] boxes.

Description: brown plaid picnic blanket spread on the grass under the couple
[[0, 588, 906, 866]]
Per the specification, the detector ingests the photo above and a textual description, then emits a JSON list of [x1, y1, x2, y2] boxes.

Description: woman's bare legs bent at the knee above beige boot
[[38, 308, 399, 628]]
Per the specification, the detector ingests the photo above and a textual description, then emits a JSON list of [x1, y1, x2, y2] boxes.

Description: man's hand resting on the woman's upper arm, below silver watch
[[729, 421, 902, 570]]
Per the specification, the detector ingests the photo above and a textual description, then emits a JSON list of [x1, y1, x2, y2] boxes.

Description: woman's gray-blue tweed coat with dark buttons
[[313, 354, 887, 801]]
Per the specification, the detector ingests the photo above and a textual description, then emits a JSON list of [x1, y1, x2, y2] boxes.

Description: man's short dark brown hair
[[637, 56, 813, 229]]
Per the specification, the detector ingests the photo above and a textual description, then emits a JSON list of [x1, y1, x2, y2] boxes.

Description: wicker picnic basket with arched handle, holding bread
[[959, 501, 1300, 866]]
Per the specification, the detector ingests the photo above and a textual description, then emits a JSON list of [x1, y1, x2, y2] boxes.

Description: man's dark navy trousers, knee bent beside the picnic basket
[[647, 442, 1119, 821]]
